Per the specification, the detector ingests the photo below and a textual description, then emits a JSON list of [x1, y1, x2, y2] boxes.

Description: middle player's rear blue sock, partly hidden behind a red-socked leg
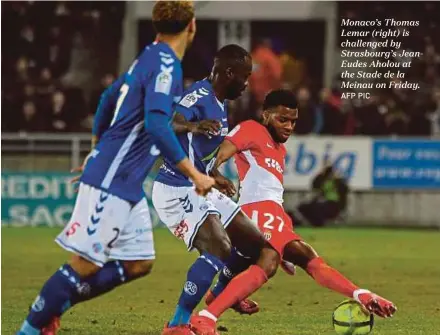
[[212, 248, 254, 297]]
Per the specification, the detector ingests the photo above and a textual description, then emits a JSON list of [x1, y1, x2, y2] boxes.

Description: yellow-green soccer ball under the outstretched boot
[[333, 300, 374, 335]]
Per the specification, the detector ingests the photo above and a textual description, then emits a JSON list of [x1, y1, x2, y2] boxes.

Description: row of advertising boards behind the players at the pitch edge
[[1, 137, 440, 226]]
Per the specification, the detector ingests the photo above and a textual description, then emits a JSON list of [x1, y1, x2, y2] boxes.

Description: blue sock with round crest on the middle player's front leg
[[169, 253, 224, 327]]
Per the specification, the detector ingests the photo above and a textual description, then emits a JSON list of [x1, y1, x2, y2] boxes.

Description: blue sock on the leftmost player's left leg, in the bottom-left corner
[[18, 264, 80, 335]]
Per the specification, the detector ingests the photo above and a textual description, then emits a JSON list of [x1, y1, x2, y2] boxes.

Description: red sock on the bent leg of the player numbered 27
[[206, 265, 267, 318]]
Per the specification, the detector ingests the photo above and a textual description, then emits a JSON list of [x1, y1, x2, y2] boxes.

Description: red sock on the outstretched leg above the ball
[[307, 257, 359, 298]]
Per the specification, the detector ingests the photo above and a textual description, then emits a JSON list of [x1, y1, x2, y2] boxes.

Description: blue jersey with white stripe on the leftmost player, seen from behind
[[81, 43, 183, 203]]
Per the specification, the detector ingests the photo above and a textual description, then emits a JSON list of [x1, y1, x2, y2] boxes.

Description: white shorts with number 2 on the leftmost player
[[55, 183, 155, 266]]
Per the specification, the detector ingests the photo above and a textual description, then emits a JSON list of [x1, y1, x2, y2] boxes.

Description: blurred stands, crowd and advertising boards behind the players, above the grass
[[2, 1, 440, 226]]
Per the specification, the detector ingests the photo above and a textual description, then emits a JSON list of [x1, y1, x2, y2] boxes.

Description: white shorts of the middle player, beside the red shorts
[[152, 181, 240, 250]]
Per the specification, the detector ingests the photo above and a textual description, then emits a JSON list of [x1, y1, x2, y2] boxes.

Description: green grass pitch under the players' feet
[[1, 228, 440, 335]]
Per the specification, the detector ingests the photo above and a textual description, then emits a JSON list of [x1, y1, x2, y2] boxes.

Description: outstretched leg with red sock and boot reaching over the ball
[[284, 241, 397, 317]]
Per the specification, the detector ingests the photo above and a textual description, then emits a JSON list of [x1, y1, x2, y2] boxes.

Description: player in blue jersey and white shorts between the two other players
[[152, 44, 266, 335]]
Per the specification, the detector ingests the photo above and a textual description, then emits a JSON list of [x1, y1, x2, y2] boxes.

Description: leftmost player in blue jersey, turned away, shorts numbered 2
[[18, 1, 214, 335]]
